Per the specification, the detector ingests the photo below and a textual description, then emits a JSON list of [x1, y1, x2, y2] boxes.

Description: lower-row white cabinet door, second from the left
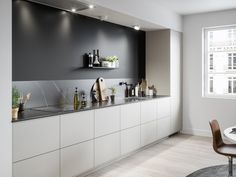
[[61, 141, 94, 177]]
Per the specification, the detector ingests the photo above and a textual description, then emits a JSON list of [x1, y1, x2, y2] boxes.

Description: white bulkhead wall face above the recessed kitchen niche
[[85, 0, 182, 31]]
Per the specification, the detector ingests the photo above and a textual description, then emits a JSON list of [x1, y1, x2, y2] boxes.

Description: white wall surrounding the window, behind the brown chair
[[183, 10, 236, 135]]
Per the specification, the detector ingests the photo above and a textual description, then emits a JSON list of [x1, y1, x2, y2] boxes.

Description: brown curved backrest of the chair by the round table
[[209, 120, 224, 151]]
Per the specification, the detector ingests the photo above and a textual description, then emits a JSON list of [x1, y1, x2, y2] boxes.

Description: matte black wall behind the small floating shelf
[[12, 0, 145, 81]]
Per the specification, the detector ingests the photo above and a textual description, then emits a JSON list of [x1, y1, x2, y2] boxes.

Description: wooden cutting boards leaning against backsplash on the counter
[[91, 77, 108, 102]]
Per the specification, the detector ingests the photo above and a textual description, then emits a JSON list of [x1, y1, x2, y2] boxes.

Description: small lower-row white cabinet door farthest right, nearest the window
[[157, 117, 170, 139]]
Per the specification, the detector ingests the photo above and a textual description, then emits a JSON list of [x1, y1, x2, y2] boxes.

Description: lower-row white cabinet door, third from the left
[[95, 133, 120, 166]]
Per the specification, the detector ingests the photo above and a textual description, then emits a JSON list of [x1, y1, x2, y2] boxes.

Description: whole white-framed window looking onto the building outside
[[203, 25, 236, 98]]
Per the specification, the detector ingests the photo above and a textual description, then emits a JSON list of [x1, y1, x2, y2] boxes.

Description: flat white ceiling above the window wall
[[152, 0, 236, 15]]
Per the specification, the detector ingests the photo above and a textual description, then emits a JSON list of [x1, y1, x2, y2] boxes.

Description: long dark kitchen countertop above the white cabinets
[[12, 95, 169, 123]]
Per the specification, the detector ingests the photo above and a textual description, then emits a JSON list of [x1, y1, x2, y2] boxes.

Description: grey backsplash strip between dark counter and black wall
[[13, 78, 137, 108]]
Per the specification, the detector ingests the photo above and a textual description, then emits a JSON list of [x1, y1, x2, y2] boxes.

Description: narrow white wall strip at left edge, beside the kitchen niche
[[0, 0, 12, 177]]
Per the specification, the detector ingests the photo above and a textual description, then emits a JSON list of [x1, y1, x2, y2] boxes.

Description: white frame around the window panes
[[202, 24, 236, 99]]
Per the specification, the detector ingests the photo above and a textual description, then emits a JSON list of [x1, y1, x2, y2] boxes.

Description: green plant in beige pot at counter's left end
[[12, 87, 20, 119]]
